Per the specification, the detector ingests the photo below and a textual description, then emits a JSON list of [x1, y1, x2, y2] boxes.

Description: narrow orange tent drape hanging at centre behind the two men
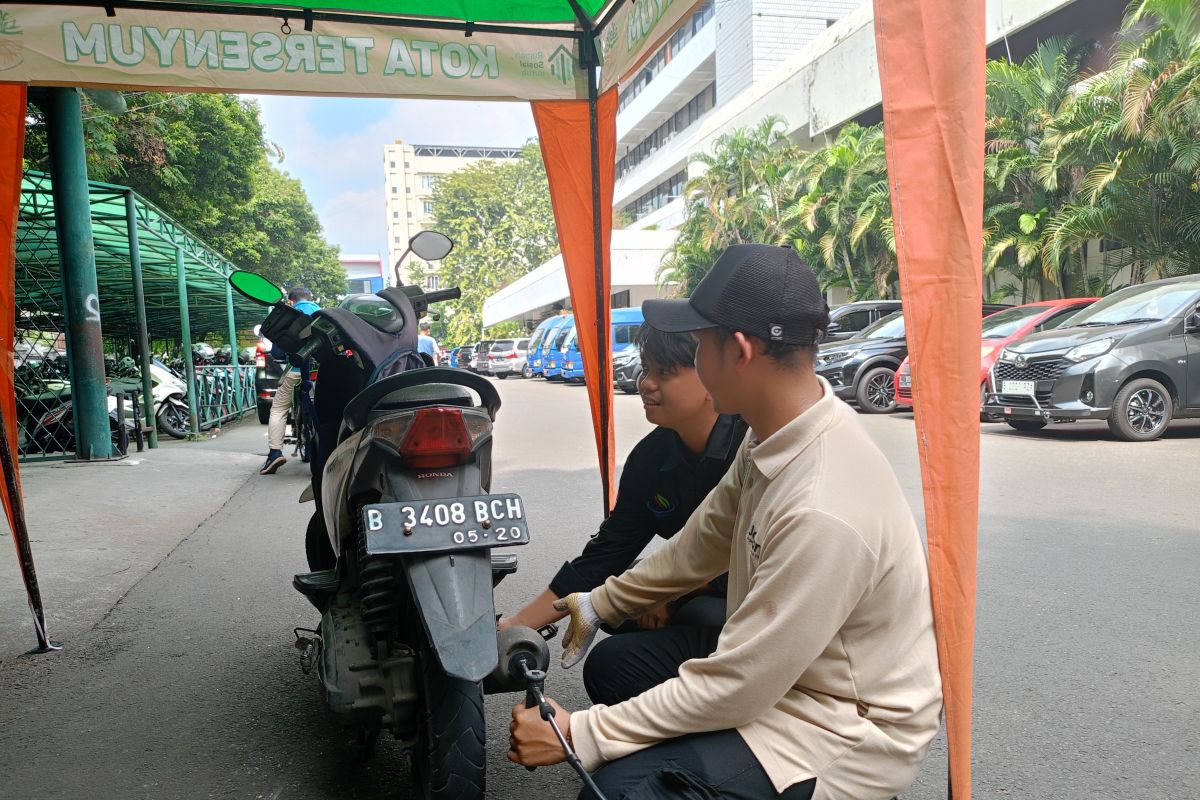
[[533, 89, 617, 515]]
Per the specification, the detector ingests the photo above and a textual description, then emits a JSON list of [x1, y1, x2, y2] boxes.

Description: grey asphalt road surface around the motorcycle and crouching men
[[0, 380, 1200, 800]]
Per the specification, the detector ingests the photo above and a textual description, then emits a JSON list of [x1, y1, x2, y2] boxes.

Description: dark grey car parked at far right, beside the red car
[[985, 275, 1200, 441]]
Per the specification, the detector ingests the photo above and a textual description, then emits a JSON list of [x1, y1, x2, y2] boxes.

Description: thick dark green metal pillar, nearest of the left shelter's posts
[[42, 89, 113, 461]]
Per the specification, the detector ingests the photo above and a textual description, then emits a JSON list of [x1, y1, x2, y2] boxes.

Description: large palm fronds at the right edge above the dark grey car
[[1039, 0, 1200, 290]]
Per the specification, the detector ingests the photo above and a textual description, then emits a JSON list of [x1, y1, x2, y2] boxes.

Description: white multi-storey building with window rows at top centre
[[613, 0, 859, 228]]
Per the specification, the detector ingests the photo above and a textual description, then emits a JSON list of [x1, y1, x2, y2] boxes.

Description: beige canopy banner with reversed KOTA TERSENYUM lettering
[[0, 0, 585, 100]]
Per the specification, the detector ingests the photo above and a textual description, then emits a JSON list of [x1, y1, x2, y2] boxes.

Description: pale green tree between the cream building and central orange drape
[[433, 143, 558, 342]]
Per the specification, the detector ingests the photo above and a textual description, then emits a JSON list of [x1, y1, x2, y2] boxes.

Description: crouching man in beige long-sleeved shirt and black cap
[[509, 245, 941, 800]]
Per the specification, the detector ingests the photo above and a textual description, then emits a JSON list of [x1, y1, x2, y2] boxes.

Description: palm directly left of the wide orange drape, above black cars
[[786, 122, 898, 300]]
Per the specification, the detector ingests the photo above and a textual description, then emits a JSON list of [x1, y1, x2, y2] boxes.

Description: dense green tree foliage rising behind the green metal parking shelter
[[25, 92, 346, 301]]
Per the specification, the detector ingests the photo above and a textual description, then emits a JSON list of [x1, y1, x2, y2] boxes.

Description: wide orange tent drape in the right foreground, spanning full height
[[875, 0, 985, 800]]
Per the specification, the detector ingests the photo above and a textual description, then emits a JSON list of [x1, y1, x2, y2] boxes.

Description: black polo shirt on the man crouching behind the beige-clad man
[[550, 414, 746, 597]]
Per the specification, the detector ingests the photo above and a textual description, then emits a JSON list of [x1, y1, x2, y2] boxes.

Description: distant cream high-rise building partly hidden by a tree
[[383, 139, 521, 289]]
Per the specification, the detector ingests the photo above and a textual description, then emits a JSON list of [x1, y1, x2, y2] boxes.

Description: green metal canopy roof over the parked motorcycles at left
[[16, 172, 265, 341]]
